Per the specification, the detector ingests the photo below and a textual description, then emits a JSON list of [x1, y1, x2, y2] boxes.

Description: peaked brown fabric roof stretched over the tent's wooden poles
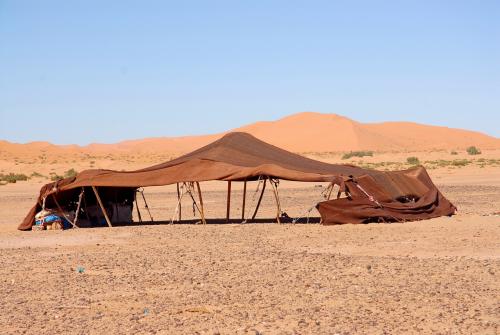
[[18, 132, 458, 230]]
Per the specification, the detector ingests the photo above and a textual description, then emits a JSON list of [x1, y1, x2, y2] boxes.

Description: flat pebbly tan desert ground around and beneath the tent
[[0, 166, 500, 334]]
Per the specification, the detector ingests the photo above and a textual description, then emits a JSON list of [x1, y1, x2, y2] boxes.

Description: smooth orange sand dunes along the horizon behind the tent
[[0, 112, 500, 157]]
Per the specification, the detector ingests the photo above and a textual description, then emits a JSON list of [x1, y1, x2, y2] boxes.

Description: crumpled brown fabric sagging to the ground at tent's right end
[[317, 167, 456, 225]]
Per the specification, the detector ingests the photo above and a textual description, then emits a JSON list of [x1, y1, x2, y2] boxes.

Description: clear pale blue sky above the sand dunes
[[0, 0, 500, 144]]
